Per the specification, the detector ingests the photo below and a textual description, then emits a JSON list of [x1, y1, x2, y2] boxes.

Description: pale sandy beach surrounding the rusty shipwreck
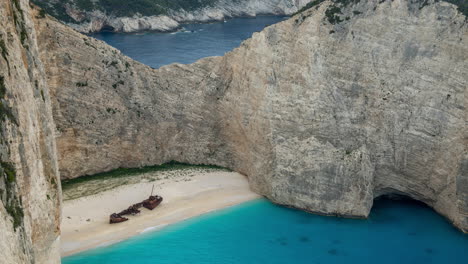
[[61, 171, 259, 256]]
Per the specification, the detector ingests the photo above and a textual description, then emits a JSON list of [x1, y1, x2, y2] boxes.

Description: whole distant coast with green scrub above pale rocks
[[33, 0, 310, 33]]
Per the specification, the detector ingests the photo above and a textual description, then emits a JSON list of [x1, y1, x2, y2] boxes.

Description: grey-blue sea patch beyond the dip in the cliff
[[91, 16, 286, 68]]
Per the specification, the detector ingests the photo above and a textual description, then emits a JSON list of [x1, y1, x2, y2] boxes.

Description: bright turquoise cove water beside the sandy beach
[[63, 199, 468, 264]]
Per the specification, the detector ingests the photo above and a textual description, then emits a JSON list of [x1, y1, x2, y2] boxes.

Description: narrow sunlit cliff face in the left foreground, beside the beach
[[0, 0, 60, 264]]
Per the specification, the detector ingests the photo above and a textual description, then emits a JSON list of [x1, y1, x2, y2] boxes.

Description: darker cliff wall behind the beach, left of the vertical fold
[[38, 22, 232, 179]]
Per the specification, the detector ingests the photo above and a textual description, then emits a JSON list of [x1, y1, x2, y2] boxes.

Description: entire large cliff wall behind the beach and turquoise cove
[[37, 0, 468, 231]]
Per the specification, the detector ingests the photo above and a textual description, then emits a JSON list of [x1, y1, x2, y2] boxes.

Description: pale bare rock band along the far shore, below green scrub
[[36, 0, 310, 33]]
